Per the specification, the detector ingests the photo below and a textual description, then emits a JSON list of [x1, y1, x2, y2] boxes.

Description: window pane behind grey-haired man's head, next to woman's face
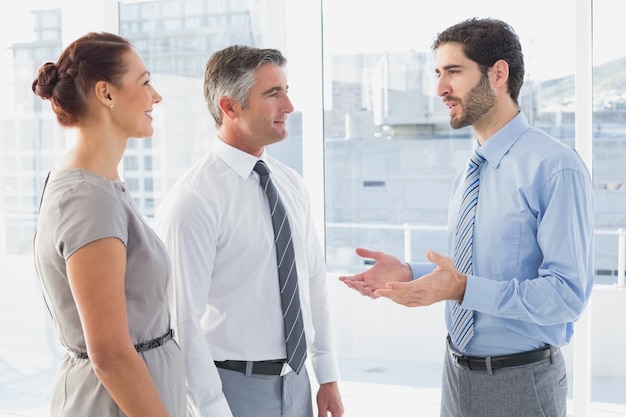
[[119, 0, 302, 218]]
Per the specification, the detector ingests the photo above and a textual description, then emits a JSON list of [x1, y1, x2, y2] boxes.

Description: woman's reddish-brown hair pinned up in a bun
[[32, 32, 132, 127]]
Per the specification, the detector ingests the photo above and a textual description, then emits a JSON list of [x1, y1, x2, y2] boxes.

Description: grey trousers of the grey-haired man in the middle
[[217, 367, 313, 417]]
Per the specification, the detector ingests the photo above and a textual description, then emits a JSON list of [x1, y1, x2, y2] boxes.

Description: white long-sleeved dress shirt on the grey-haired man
[[155, 138, 339, 417]]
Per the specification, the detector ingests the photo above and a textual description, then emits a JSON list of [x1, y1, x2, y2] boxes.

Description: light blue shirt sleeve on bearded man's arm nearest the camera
[[463, 170, 593, 325]]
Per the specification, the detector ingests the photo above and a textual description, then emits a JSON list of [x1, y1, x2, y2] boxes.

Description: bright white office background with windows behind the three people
[[0, 0, 626, 417]]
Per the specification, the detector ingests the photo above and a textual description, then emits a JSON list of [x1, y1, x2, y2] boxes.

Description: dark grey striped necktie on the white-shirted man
[[254, 161, 306, 373]]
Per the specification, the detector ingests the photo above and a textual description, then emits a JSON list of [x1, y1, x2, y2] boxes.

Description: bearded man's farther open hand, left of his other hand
[[339, 248, 413, 298]]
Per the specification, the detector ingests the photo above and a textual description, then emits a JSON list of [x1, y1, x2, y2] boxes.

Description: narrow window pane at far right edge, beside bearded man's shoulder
[[593, 0, 626, 285]]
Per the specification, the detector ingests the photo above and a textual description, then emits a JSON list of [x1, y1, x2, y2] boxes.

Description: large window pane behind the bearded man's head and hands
[[324, 0, 575, 272]]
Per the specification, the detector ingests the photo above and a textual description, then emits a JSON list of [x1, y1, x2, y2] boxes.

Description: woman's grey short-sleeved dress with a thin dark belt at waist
[[34, 169, 187, 417]]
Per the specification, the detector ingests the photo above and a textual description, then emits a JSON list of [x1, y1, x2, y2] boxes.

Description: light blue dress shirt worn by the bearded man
[[410, 112, 594, 356]]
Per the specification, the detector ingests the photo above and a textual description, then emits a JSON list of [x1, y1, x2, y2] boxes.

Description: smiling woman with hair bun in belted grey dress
[[32, 33, 187, 417]]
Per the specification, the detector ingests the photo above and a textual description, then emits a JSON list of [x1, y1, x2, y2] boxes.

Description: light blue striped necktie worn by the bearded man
[[450, 150, 485, 351]]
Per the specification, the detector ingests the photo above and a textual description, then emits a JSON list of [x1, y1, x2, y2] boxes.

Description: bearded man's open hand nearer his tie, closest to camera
[[373, 250, 467, 307]]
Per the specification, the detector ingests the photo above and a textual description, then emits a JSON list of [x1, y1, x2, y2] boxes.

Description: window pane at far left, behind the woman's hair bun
[[0, 6, 65, 255]]
